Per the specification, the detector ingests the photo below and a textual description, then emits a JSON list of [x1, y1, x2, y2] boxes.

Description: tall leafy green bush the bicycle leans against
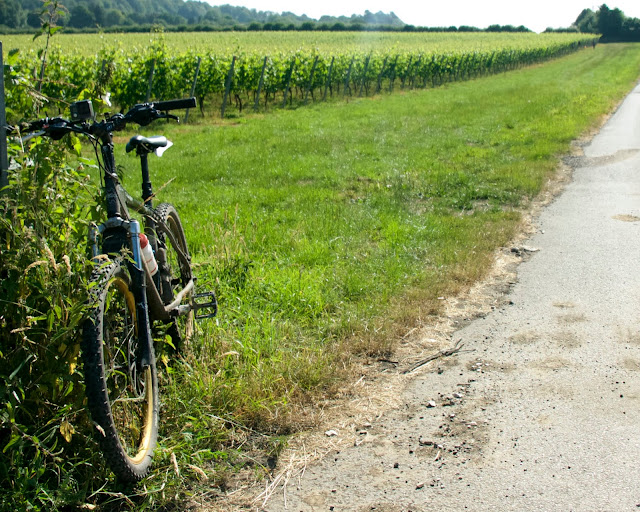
[[0, 81, 104, 510]]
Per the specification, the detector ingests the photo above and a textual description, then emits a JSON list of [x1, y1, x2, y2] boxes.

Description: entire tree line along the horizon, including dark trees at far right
[[0, 0, 640, 37]]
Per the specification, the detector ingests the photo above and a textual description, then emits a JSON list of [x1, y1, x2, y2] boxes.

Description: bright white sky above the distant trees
[[206, 0, 640, 32]]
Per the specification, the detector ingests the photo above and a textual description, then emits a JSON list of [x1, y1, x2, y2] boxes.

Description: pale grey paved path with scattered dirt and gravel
[[264, 87, 640, 512]]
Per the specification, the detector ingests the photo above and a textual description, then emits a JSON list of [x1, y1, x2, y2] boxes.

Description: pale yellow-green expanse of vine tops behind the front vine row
[[2, 32, 596, 56]]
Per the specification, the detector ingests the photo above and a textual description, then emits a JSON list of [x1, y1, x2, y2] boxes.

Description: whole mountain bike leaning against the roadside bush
[[23, 98, 217, 482]]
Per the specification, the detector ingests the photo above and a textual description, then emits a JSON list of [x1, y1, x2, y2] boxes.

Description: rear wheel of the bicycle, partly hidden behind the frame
[[156, 203, 194, 348]]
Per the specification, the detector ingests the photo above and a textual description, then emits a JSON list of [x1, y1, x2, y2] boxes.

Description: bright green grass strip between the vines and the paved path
[[76, 45, 640, 505]]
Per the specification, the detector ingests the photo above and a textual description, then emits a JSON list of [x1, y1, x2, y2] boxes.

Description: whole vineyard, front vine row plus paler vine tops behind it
[[8, 33, 594, 117]]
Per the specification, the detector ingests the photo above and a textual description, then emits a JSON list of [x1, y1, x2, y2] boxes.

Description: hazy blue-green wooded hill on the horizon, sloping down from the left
[[0, 0, 405, 31]]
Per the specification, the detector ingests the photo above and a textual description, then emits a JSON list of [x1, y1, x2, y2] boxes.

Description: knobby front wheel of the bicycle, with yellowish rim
[[82, 260, 158, 482]]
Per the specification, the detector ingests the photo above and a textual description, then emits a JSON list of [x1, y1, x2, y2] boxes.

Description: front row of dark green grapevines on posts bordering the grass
[[16, 36, 592, 117]]
